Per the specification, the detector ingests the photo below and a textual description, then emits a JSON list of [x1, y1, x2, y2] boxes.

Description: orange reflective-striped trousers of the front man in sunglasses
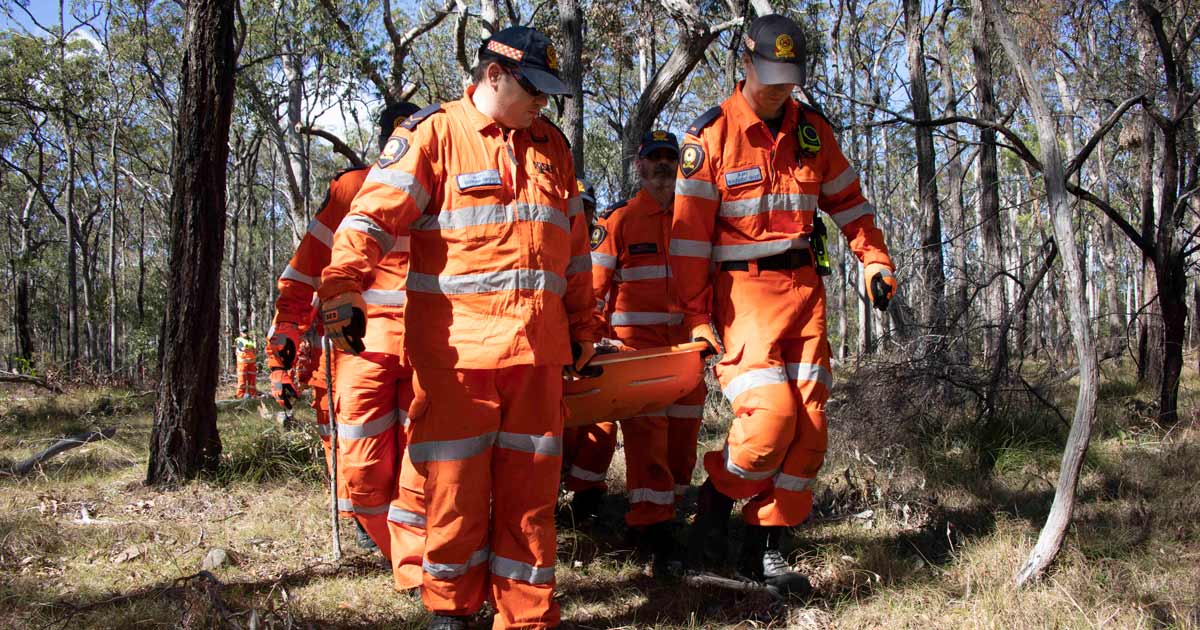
[[408, 365, 565, 628]]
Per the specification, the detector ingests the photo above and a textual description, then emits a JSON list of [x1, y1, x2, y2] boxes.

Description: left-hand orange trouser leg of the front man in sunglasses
[[408, 368, 500, 614]]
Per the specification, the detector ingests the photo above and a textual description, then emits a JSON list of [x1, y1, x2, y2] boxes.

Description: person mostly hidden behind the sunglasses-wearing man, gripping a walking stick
[[268, 103, 424, 590]]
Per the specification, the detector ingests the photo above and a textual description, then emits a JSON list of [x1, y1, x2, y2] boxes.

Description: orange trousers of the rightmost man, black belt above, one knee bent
[[704, 262, 833, 526]]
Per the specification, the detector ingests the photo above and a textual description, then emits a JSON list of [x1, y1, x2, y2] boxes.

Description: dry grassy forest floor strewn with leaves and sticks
[[0, 358, 1200, 629]]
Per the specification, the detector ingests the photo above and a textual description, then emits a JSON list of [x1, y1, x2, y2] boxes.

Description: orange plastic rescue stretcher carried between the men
[[563, 341, 708, 427]]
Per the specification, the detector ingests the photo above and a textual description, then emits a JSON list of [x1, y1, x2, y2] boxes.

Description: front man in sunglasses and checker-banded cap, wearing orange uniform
[[319, 26, 602, 630]]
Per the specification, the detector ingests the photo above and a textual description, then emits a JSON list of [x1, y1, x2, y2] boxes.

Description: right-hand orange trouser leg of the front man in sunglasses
[[490, 366, 565, 628]]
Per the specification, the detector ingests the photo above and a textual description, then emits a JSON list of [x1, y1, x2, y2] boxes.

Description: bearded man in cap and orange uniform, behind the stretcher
[[571, 130, 707, 574]]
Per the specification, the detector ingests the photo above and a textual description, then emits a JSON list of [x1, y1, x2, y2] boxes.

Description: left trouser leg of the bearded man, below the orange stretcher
[[620, 415, 674, 527]]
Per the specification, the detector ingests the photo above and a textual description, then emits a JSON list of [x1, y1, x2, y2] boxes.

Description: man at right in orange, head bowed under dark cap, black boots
[[671, 16, 896, 593]]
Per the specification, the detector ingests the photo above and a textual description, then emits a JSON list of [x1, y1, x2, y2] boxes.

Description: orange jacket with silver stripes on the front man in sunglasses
[[319, 89, 602, 362]]
